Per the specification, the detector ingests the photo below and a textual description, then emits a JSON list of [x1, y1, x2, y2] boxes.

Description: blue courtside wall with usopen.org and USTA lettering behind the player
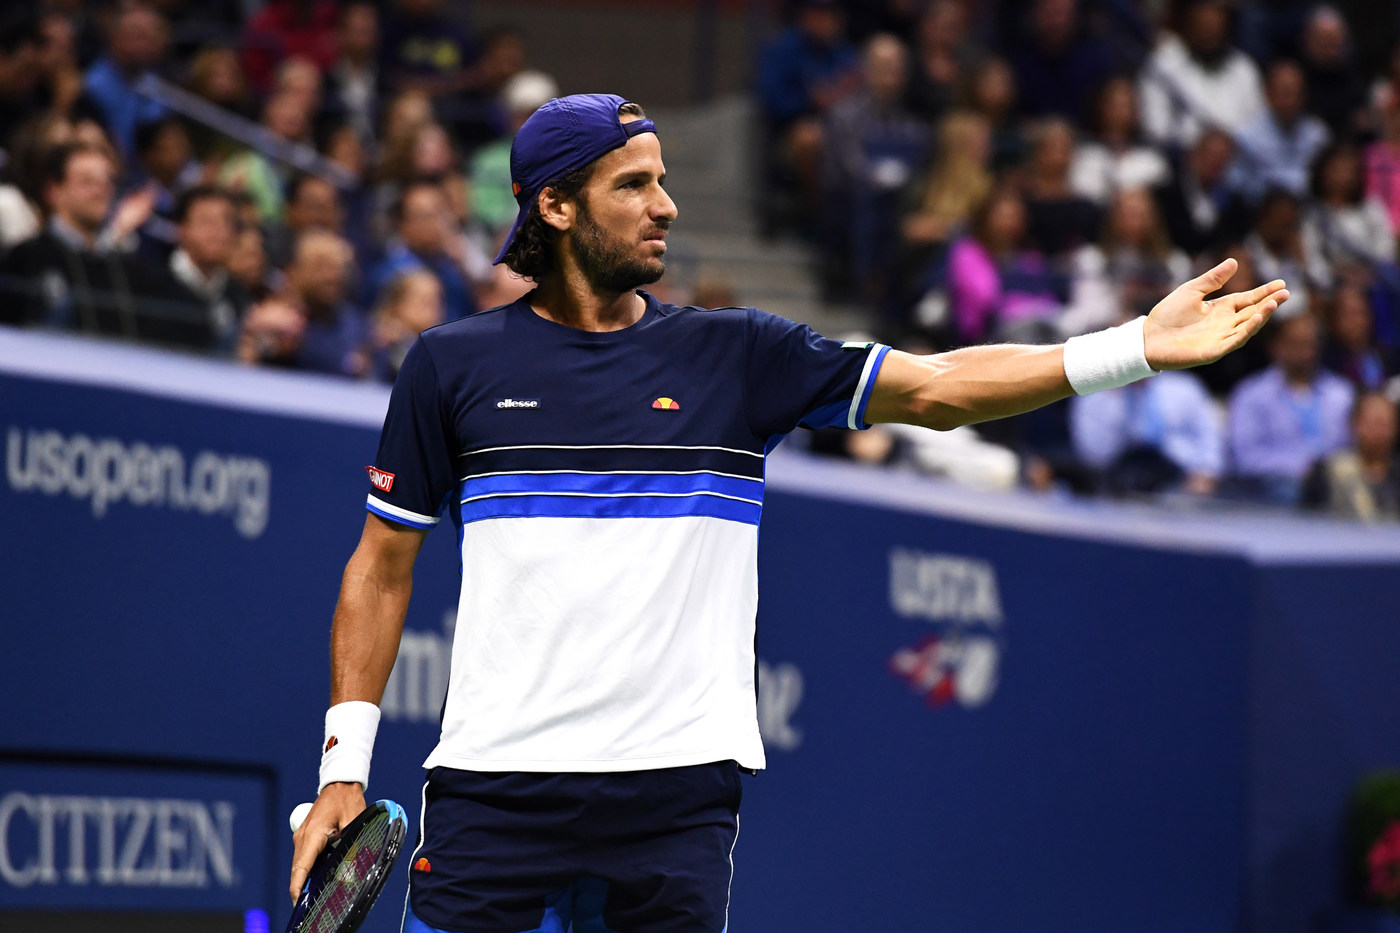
[[0, 329, 1400, 933]]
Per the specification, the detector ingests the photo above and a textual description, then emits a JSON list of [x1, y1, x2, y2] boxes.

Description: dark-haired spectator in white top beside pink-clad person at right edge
[[1303, 143, 1396, 266]]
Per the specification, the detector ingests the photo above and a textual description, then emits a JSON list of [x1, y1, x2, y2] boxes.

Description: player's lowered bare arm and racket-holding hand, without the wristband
[[291, 514, 427, 901]]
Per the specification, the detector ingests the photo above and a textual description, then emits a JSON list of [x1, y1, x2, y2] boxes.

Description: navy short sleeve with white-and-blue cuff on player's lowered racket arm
[[365, 339, 456, 530]]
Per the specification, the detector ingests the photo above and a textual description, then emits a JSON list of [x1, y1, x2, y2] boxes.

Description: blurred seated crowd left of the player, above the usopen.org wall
[[0, 0, 574, 381]]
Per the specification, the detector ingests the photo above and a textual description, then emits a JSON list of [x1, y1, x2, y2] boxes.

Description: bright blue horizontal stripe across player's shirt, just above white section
[[462, 493, 763, 525]]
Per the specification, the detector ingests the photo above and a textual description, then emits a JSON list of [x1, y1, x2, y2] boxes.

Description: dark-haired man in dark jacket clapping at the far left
[[0, 143, 157, 334]]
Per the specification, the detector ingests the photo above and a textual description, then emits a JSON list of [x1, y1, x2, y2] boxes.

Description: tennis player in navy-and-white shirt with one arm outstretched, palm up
[[291, 94, 1288, 933]]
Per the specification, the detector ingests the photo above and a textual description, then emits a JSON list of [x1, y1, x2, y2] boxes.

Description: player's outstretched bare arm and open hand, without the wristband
[[865, 259, 1288, 430]]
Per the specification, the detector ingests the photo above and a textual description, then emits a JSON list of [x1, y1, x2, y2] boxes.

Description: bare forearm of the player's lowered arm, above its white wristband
[[330, 551, 413, 705]]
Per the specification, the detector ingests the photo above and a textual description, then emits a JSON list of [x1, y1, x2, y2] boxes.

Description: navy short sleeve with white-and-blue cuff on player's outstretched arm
[[745, 308, 889, 437]]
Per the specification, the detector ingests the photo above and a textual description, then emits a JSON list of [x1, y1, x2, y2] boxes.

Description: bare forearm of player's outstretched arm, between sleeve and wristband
[[865, 345, 1072, 430]]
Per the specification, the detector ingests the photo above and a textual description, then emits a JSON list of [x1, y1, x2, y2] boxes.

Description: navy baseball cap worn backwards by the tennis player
[[491, 94, 657, 265]]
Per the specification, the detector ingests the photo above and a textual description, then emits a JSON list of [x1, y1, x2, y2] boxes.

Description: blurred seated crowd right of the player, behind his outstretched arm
[[756, 0, 1400, 520]]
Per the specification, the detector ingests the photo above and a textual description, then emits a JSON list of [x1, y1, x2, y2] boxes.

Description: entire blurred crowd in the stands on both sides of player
[[0, 0, 1400, 518]]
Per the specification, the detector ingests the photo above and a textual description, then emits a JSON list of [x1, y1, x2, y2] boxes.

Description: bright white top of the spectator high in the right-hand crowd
[[1140, 35, 1264, 148]]
